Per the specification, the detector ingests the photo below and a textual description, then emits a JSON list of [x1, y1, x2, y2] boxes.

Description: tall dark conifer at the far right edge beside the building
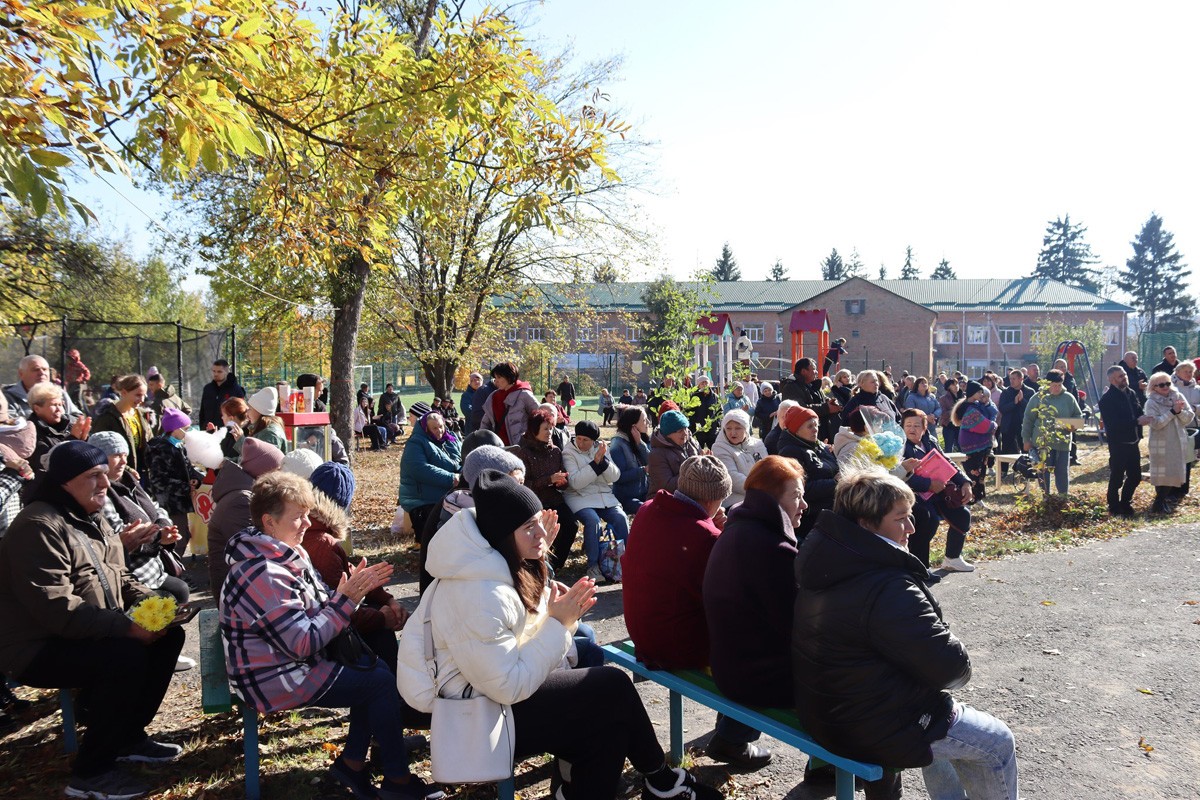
[[1117, 213, 1196, 333]]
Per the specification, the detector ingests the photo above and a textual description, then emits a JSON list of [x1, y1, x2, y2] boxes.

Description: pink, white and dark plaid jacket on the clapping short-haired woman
[[221, 528, 354, 714]]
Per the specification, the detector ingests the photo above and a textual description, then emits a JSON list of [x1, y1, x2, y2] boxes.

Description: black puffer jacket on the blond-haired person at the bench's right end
[[792, 511, 971, 769]]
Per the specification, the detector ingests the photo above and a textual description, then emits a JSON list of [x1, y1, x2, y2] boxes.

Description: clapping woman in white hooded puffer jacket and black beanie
[[396, 470, 722, 800]]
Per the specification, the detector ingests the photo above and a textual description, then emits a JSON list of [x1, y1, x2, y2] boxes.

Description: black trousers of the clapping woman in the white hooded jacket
[[512, 667, 666, 800]]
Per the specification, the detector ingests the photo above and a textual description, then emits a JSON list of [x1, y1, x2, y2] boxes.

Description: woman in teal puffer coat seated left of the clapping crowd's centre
[[400, 411, 461, 530]]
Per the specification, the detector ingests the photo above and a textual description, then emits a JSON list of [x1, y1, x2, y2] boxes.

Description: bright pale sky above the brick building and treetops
[[72, 0, 1200, 295]]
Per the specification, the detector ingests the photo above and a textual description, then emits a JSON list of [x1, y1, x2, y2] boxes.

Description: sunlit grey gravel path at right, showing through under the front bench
[[566, 525, 1200, 800]]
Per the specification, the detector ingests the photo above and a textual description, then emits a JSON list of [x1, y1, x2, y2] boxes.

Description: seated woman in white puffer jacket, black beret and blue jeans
[[563, 420, 629, 581]]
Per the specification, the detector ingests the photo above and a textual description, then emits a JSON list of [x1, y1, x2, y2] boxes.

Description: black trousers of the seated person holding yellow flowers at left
[[17, 627, 185, 777]]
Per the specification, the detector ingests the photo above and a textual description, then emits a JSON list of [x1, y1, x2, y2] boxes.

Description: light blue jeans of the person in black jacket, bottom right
[[922, 705, 1017, 800]]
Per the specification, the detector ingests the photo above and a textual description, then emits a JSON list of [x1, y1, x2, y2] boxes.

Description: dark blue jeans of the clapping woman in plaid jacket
[[308, 661, 408, 780]]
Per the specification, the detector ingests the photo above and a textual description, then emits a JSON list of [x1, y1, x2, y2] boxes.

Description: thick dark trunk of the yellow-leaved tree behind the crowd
[[329, 252, 371, 449]]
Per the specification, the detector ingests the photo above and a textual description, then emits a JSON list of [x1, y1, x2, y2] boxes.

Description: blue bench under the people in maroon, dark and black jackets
[[604, 639, 883, 800]]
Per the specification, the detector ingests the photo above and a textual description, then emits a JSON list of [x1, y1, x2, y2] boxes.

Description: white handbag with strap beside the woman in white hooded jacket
[[421, 581, 516, 783]]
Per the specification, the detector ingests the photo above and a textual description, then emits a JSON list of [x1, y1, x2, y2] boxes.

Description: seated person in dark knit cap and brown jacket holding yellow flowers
[[0, 440, 184, 798]]
